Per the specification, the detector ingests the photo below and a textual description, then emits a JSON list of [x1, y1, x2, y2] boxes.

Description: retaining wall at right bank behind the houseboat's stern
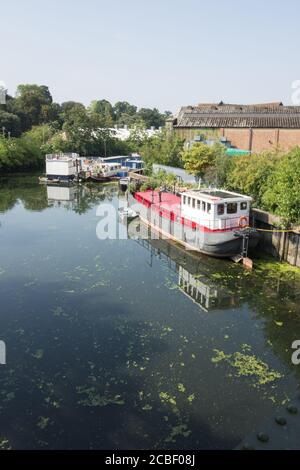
[[252, 209, 300, 267]]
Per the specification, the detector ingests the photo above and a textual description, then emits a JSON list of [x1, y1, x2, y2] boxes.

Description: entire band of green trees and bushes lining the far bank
[[0, 85, 300, 223]]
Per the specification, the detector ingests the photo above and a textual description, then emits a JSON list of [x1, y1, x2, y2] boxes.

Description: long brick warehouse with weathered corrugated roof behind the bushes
[[166, 102, 300, 152]]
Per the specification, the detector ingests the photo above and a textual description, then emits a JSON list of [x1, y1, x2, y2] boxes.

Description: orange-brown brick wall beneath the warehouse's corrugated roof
[[174, 128, 300, 153]]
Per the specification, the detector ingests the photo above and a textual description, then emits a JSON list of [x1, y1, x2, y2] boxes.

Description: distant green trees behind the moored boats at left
[[0, 85, 171, 173]]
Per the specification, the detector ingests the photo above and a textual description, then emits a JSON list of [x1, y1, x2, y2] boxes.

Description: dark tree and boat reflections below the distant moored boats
[[0, 175, 117, 214]]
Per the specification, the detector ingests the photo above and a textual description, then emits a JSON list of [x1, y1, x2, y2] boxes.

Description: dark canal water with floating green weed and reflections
[[0, 175, 300, 449]]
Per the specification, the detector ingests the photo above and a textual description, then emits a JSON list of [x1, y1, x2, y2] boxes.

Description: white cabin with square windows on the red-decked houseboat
[[181, 189, 252, 230]]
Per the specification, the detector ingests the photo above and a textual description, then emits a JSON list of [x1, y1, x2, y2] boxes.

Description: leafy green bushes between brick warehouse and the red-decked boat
[[182, 143, 300, 223]]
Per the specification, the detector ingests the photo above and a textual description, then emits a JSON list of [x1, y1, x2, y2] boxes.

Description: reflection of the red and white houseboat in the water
[[128, 221, 238, 312]]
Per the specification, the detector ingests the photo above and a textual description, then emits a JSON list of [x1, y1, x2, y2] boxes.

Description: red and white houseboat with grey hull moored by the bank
[[129, 189, 258, 257]]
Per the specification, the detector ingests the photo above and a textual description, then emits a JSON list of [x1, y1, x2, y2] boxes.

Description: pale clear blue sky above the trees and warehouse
[[0, 0, 300, 111]]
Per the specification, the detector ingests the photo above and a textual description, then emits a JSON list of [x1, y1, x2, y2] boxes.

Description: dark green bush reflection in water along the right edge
[[209, 262, 300, 384]]
